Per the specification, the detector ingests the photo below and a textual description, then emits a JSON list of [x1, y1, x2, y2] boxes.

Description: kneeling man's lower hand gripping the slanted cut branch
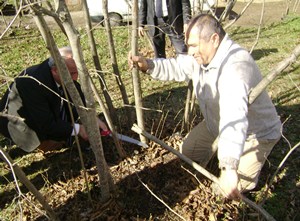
[[219, 169, 241, 200]]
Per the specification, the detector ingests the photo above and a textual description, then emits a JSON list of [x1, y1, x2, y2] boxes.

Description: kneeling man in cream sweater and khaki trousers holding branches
[[129, 14, 281, 199]]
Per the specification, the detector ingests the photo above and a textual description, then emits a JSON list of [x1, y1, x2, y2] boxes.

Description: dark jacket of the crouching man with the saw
[[0, 59, 85, 148]]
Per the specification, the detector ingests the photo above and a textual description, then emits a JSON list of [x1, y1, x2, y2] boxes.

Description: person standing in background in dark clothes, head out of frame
[[139, 0, 191, 58]]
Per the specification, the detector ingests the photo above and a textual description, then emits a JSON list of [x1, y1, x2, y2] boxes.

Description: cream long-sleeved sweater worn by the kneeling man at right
[[148, 35, 281, 160]]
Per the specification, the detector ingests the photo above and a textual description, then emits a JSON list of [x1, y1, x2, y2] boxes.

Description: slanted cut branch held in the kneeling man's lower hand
[[131, 124, 275, 221]]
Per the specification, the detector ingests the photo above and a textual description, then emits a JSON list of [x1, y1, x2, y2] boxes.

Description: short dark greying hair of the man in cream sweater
[[186, 14, 226, 43]]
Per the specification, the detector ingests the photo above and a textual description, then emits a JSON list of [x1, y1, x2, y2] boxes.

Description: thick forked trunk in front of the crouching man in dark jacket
[[32, 0, 114, 202]]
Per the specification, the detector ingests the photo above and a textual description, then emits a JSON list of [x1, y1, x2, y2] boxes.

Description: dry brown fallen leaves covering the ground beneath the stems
[[5, 136, 243, 221]]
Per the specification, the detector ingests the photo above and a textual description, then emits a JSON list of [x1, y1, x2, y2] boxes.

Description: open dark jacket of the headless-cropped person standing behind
[[139, 0, 191, 36]]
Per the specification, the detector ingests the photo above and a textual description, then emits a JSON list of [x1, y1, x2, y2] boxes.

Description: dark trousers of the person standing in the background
[[152, 19, 187, 58]]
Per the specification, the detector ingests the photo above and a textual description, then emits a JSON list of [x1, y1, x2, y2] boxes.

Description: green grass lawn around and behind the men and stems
[[0, 16, 300, 220]]
